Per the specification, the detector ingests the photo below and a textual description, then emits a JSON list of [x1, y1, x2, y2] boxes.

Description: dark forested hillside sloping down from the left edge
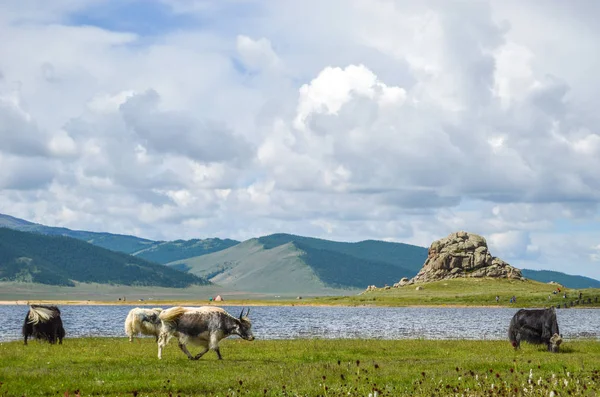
[[0, 228, 209, 288]]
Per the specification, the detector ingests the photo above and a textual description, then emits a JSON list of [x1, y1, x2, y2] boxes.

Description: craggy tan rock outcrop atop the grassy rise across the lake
[[406, 231, 523, 286]]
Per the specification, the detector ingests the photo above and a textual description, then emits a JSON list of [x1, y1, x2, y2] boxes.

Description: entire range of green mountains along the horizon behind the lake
[[0, 214, 600, 294]]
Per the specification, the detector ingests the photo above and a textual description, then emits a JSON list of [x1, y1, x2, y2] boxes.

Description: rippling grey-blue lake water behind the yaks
[[0, 305, 600, 342]]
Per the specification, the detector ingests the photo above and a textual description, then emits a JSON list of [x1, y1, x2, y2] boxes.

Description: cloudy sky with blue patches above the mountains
[[0, 0, 600, 279]]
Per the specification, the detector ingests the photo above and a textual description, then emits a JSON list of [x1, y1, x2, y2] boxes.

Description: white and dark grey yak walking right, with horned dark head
[[158, 306, 254, 360]]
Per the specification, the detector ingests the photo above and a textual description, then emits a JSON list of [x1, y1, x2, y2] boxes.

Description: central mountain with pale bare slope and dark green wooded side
[[167, 234, 427, 293]]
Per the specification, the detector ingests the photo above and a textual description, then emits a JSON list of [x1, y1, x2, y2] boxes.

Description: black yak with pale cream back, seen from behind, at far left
[[23, 305, 65, 345]]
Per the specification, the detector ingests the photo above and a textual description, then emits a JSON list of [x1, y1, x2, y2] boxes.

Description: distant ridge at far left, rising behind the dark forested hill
[[0, 214, 155, 254]]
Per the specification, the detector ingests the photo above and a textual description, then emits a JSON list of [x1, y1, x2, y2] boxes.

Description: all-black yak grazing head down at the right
[[508, 307, 562, 353]]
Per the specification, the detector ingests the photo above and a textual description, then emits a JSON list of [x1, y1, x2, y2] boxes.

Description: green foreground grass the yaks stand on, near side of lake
[[0, 338, 600, 396]]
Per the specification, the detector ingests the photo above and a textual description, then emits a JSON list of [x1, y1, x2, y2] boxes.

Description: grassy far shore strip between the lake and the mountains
[[0, 278, 600, 308]]
